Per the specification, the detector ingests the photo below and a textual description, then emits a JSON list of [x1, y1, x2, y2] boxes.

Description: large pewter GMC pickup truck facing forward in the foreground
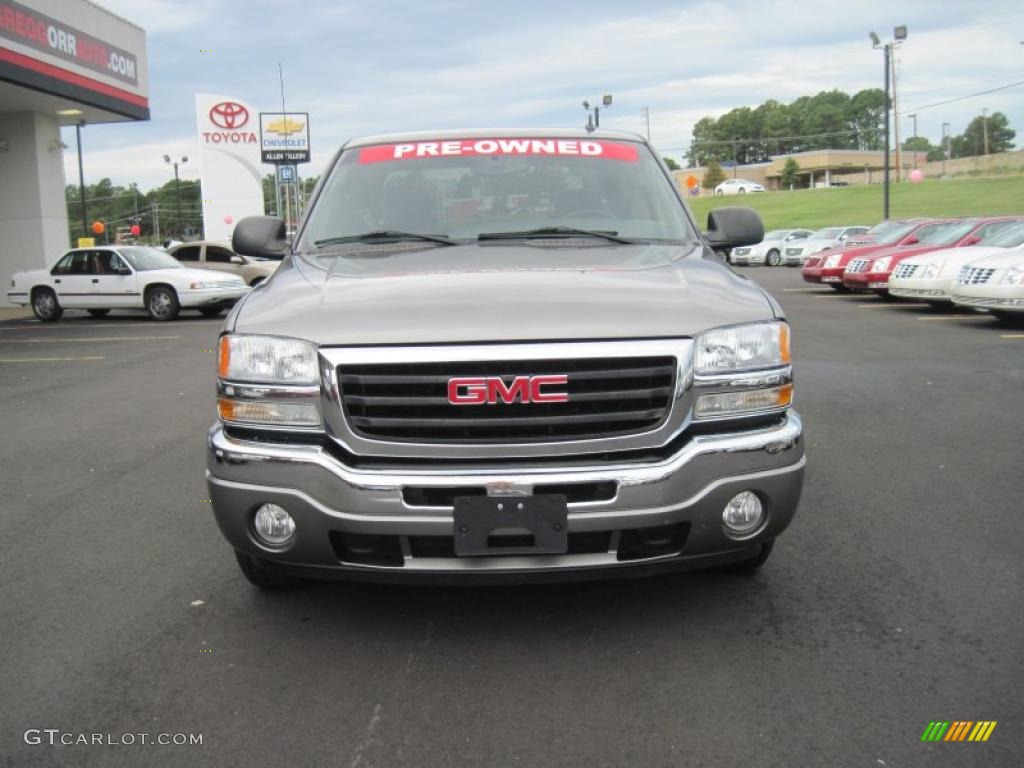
[[207, 130, 805, 588]]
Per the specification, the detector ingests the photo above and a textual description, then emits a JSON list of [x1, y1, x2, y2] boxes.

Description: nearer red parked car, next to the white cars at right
[[843, 217, 1020, 296]]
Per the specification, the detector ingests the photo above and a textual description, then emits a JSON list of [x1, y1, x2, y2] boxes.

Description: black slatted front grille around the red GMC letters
[[338, 356, 676, 442]]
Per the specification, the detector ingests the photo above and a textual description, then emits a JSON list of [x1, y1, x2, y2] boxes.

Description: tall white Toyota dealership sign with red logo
[[196, 93, 263, 240]]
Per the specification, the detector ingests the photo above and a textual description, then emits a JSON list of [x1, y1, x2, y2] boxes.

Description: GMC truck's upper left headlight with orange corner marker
[[217, 334, 319, 384]]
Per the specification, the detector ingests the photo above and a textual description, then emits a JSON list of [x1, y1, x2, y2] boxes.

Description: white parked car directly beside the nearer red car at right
[[889, 222, 1024, 304]]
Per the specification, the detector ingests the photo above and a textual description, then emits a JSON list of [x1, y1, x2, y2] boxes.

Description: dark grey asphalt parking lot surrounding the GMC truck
[[0, 268, 1024, 768]]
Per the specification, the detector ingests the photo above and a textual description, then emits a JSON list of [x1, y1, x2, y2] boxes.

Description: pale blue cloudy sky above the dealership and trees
[[63, 0, 1024, 189]]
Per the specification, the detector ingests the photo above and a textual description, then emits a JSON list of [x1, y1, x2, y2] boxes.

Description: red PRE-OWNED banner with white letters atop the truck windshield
[[359, 138, 638, 163]]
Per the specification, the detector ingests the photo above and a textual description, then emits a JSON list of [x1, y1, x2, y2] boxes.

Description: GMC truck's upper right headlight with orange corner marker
[[693, 323, 792, 374]]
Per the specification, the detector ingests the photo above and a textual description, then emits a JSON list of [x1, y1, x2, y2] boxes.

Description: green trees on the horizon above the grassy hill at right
[[687, 88, 1016, 167]]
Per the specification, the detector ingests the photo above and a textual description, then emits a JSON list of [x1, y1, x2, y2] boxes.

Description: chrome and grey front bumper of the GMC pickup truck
[[207, 411, 805, 578]]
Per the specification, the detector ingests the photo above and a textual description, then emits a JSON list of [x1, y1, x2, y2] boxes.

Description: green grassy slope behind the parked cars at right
[[689, 176, 1024, 229]]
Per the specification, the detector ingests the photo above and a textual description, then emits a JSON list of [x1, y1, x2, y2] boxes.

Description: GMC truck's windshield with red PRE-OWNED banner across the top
[[298, 138, 694, 252]]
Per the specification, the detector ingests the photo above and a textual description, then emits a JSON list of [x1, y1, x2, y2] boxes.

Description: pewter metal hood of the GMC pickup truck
[[232, 241, 775, 345]]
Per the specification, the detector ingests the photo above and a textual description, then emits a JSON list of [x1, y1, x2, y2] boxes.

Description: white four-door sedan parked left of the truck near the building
[[7, 246, 249, 323]]
